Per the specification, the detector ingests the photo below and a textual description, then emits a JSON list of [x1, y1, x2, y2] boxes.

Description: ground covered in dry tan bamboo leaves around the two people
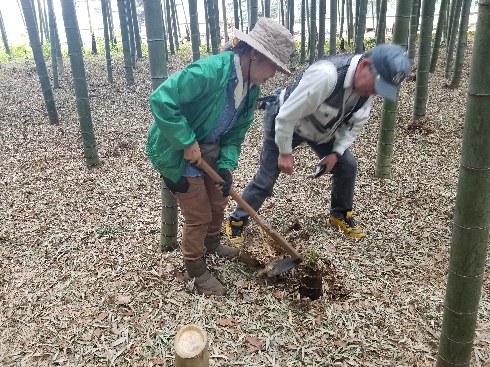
[[0, 43, 490, 366]]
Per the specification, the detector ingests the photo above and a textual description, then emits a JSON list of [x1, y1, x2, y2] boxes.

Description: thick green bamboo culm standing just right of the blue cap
[[413, 0, 435, 119]]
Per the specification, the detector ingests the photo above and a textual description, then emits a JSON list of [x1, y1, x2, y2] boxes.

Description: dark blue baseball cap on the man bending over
[[366, 44, 410, 102]]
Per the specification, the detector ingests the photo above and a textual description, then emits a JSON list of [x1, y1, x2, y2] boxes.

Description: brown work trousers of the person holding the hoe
[[172, 175, 228, 260]]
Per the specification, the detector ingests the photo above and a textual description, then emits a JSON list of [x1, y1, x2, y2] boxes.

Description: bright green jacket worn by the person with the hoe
[[146, 51, 260, 182]]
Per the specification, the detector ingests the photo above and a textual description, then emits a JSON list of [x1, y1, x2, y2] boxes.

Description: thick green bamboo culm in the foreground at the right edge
[[436, 0, 490, 367]]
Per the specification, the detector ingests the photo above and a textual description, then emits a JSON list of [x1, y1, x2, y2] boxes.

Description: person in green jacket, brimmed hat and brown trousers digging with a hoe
[[146, 18, 294, 295]]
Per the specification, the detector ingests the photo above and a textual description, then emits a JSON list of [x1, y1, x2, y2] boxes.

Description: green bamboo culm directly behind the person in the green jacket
[[143, 0, 178, 251]]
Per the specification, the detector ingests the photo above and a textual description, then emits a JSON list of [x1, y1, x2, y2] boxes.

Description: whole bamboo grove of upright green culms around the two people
[[0, 0, 490, 367]]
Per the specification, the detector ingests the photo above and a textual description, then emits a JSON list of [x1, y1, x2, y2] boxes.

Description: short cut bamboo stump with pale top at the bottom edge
[[174, 324, 209, 367]]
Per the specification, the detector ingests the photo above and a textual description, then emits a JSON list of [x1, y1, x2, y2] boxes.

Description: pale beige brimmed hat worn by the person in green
[[235, 18, 294, 74]]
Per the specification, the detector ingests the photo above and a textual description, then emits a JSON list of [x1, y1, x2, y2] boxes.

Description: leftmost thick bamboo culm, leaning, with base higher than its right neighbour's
[[21, 0, 59, 124]]
